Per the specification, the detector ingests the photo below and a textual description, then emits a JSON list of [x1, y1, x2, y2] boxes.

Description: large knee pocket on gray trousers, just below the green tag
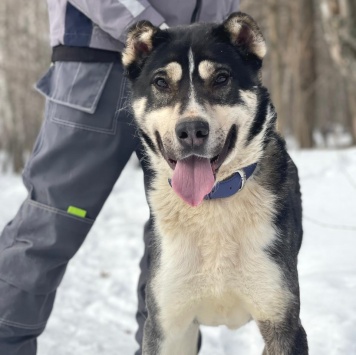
[[0, 200, 93, 295]]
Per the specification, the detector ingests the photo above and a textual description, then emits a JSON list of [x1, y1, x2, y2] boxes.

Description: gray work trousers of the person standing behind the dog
[[0, 62, 151, 355]]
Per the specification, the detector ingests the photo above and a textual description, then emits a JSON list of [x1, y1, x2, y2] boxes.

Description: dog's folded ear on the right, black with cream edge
[[223, 12, 267, 60]]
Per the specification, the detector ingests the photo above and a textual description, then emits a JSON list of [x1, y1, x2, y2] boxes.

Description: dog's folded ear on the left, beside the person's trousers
[[122, 21, 160, 79]]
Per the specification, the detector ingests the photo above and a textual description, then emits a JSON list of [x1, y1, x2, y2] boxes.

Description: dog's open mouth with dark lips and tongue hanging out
[[160, 125, 237, 206]]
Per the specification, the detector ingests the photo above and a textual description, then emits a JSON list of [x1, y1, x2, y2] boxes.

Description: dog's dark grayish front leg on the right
[[258, 319, 308, 355]]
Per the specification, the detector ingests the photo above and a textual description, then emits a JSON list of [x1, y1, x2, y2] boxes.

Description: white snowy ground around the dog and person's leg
[[0, 149, 356, 355]]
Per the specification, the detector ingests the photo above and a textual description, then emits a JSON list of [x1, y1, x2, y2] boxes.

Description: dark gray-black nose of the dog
[[176, 121, 209, 147]]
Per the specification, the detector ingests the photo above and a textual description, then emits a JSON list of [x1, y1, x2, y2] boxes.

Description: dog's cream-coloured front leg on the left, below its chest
[[142, 317, 199, 355]]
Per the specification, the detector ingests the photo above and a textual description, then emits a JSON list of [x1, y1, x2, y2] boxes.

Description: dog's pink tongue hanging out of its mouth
[[172, 156, 215, 206]]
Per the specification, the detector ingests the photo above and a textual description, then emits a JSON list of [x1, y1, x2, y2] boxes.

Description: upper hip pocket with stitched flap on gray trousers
[[36, 62, 126, 135]]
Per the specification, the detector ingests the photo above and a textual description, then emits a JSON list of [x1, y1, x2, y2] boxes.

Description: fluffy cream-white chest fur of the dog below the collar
[[150, 181, 289, 331]]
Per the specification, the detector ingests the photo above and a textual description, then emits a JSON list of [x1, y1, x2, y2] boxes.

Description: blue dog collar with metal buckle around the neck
[[168, 163, 257, 200]]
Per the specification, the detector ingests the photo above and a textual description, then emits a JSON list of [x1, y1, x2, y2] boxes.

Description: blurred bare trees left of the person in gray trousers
[[0, 0, 49, 171]]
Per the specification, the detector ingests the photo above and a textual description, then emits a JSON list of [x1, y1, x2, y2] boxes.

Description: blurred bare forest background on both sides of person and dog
[[0, 0, 356, 171]]
